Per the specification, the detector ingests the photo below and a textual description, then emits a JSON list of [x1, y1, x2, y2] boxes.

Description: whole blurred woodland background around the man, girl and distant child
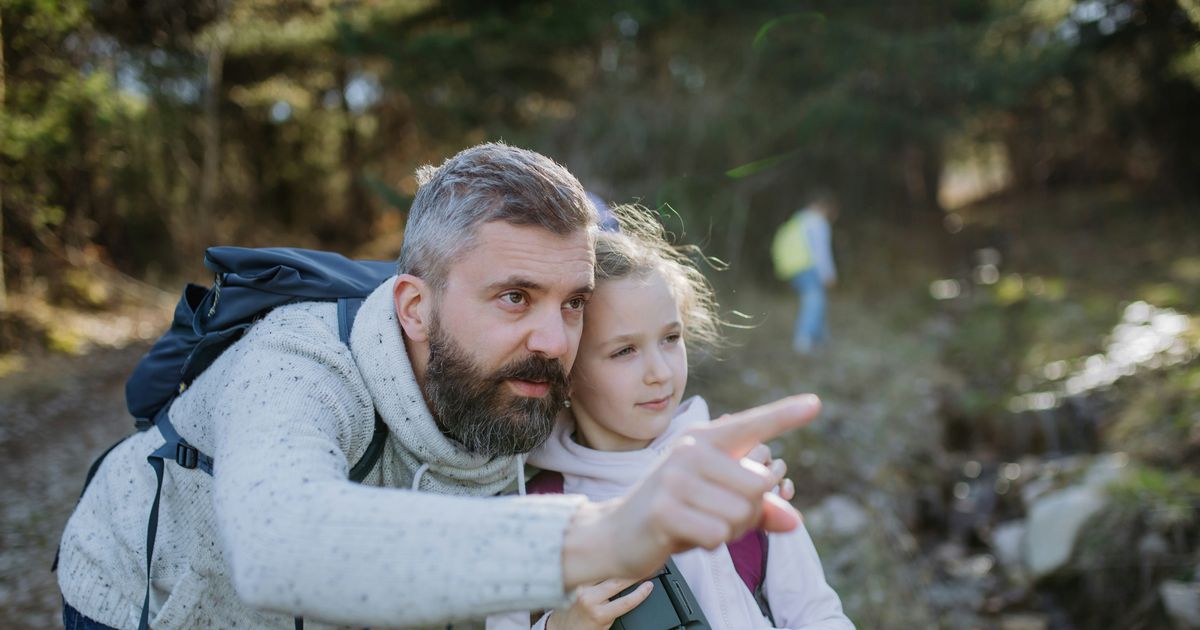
[[0, 0, 1200, 630]]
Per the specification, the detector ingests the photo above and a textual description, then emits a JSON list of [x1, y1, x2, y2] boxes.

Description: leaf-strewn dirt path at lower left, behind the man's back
[[0, 346, 145, 628]]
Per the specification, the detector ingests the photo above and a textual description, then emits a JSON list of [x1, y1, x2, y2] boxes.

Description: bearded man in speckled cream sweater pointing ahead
[[59, 144, 817, 628]]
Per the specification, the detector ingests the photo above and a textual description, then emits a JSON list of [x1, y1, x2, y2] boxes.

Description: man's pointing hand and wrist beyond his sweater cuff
[[563, 395, 821, 588]]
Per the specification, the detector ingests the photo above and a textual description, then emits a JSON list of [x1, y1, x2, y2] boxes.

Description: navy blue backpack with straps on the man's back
[[63, 247, 395, 629]]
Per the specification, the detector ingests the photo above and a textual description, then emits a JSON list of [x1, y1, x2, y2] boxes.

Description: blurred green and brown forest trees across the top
[[0, 0, 1200, 290]]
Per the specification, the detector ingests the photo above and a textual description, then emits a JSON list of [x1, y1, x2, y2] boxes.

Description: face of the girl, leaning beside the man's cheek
[[571, 274, 688, 451]]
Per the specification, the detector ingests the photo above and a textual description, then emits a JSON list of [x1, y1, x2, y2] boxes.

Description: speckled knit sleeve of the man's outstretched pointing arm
[[214, 319, 582, 626]]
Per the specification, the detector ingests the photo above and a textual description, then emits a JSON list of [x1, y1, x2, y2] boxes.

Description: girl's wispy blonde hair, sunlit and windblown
[[595, 204, 726, 350]]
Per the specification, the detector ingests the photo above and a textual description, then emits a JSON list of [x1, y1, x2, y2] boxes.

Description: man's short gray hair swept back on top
[[396, 143, 596, 290]]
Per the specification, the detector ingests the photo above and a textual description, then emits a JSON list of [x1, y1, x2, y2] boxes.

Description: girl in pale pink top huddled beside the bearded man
[[487, 206, 853, 630]]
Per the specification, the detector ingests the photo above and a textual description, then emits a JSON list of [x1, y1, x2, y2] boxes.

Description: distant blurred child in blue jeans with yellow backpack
[[770, 191, 838, 354]]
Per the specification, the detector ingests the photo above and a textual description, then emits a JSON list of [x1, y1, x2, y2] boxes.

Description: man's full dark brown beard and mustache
[[425, 322, 569, 456]]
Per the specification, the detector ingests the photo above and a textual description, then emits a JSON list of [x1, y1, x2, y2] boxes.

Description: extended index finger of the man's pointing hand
[[701, 394, 821, 457]]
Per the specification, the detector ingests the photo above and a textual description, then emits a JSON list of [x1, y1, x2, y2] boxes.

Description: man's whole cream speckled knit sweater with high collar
[[59, 281, 581, 629]]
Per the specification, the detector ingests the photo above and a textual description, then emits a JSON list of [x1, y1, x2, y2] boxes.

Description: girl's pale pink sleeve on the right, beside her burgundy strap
[[763, 524, 854, 630]]
